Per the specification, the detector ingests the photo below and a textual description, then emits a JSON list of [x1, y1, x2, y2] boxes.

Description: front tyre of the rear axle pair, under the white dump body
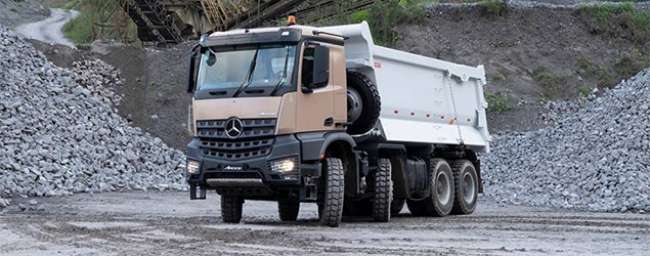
[[407, 158, 455, 217]]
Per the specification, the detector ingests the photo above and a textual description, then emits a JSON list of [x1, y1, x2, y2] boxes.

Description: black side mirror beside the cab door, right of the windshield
[[302, 45, 330, 93]]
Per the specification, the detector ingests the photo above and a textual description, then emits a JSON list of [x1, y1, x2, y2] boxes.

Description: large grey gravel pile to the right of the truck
[[483, 69, 650, 212]]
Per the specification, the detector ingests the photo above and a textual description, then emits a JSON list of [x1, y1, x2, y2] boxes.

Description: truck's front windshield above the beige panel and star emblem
[[197, 45, 296, 93]]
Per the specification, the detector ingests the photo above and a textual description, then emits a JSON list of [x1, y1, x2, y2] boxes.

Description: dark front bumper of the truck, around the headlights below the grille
[[187, 135, 320, 199]]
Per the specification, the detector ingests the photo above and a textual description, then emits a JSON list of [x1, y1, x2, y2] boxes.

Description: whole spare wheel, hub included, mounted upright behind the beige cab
[[347, 71, 381, 134]]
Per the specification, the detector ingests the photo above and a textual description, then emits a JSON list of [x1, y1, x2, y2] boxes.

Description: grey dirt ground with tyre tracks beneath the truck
[[0, 192, 650, 256]]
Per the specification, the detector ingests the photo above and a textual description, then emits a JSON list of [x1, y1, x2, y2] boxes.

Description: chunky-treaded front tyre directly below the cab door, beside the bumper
[[319, 157, 345, 227]]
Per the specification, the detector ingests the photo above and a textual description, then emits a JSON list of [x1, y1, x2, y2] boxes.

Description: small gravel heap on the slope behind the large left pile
[[72, 59, 124, 106]]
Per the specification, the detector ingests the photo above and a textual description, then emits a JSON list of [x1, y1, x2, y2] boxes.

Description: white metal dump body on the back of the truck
[[318, 22, 490, 152]]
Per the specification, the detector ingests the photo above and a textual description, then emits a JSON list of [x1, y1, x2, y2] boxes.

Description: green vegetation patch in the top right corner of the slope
[[578, 2, 650, 44]]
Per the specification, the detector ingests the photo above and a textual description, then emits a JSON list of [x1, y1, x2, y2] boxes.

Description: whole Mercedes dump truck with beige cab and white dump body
[[182, 22, 490, 227]]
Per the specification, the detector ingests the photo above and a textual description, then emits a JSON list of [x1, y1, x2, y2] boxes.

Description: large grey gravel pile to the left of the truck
[[0, 26, 185, 207]]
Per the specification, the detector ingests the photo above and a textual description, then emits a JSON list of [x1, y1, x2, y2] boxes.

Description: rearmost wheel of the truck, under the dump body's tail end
[[451, 160, 479, 215]]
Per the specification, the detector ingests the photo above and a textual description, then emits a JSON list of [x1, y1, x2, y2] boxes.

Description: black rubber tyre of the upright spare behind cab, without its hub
[[347, 72, 381, 134]]
